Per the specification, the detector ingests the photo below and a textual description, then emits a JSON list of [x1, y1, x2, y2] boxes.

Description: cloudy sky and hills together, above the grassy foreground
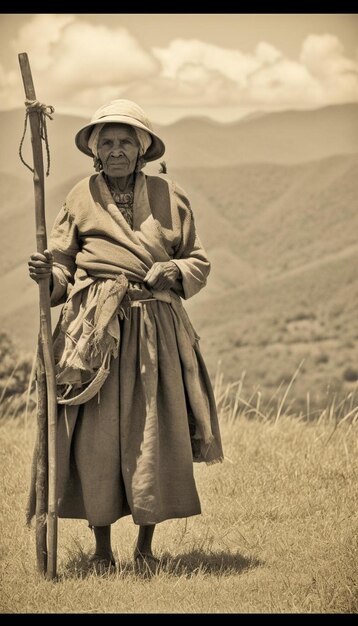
[[0, 14, 358, 411]]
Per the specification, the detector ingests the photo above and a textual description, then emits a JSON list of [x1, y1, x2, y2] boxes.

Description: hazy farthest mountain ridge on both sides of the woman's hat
[[0, 104, 358, 189]]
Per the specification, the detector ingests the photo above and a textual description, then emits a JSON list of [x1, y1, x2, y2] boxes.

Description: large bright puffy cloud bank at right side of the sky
[[146, 35, 358, 109]]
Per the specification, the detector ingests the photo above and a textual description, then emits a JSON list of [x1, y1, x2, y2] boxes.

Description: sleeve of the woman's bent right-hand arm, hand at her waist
[[173, 185, 210, 300]]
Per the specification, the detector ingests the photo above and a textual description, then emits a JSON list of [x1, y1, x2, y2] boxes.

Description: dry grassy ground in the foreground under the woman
[[0, 404, 358, 613]]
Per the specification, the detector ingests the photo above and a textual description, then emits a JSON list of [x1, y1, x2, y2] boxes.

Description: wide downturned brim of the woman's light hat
[[75, 115, 165, 161]]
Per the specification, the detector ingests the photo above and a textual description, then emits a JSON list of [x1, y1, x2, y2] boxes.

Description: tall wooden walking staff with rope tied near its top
[[19, 52, 57, 579]]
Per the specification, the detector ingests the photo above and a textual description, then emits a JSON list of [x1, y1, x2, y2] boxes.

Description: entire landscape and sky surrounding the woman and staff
[[0, 14, 358, 614]]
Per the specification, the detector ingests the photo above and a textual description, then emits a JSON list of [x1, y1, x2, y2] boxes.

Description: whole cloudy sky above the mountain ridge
[[0, 13, 358, 124]]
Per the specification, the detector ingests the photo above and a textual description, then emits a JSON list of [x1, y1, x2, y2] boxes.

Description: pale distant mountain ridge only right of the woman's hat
[[160, 104, 358, 167]]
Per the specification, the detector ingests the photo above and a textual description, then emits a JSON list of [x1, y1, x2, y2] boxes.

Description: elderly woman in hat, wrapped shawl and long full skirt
[[29, 100, 223, 567]]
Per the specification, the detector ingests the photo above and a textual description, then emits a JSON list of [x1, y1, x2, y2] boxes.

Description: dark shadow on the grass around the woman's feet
[[63, 550, 264, 578]]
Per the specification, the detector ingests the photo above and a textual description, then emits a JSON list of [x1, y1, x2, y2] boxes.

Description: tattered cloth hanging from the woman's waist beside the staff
[[54, 272, 128, 404]]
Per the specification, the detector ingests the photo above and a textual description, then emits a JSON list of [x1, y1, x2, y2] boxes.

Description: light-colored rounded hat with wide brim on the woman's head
[[75, 100, 165, 161]]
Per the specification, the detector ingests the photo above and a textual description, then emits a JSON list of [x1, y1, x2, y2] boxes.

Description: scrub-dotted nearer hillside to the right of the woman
[[178, 156, 358, 412]]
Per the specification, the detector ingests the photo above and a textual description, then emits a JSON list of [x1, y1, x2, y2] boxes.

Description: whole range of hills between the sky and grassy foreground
[[0, 105, 358, 410]]
